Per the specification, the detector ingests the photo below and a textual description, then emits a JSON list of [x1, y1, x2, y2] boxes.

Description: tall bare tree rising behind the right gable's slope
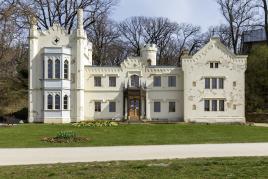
[[217, 0, 255, 54]]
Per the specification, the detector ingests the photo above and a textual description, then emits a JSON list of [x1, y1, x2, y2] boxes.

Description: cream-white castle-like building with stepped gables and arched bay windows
[[29, 10, 247, 123]]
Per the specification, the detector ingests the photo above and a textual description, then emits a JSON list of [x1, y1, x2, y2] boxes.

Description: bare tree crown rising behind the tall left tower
[[19, 0, 117, 33]]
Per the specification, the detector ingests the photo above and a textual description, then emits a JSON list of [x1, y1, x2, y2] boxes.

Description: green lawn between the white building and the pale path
[[0, 124, 268, 147]]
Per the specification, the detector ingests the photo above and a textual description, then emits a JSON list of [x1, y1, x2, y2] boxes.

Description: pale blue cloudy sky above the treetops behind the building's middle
[[112, 0, 224, 31]]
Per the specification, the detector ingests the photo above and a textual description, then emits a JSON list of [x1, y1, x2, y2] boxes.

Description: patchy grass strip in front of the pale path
[[0, 157, 268, 179]]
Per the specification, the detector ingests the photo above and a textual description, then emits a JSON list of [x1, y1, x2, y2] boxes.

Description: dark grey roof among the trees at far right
[[243, 29, 266, 43]]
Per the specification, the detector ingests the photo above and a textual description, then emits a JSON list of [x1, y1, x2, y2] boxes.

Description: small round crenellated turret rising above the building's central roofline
[[141, 44, 157, 66]]
